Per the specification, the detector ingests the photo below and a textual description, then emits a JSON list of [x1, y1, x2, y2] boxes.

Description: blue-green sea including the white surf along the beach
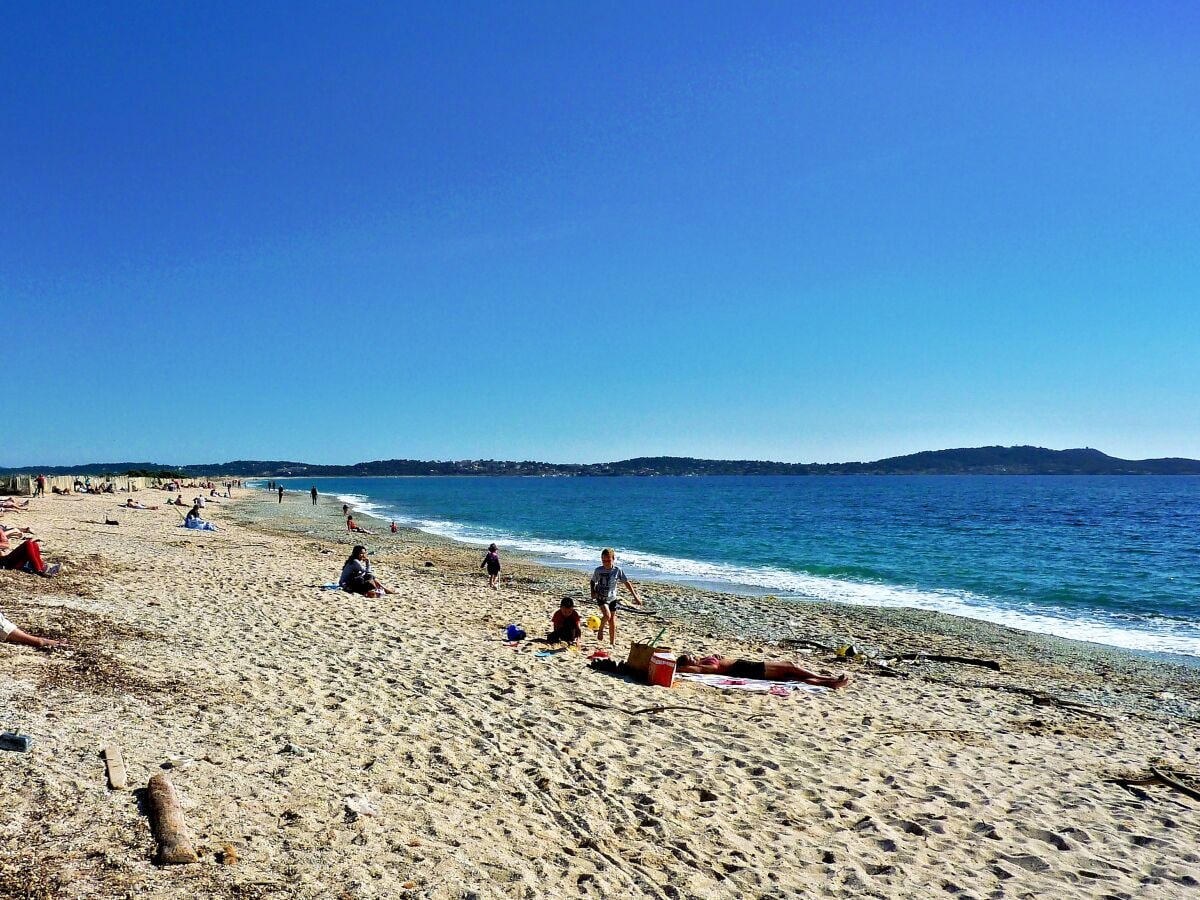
[[272, 476, 1200, 656]]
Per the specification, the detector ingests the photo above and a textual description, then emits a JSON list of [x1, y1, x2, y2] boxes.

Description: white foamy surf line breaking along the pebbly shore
[[338, 493, 1200, 656]]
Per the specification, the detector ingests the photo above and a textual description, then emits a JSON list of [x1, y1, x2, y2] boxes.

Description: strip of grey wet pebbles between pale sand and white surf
[[238, 488, 1200, 721]]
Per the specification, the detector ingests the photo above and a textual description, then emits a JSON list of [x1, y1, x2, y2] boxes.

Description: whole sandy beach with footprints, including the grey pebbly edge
[[0, 491, 1200, 899]]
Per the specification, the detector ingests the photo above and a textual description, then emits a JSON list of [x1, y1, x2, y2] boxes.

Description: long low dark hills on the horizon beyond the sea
[[0, 446, 1200, 478]]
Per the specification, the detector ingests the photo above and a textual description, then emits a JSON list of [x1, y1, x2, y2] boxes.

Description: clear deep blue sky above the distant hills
[[0, 2, 1200, 466]]
